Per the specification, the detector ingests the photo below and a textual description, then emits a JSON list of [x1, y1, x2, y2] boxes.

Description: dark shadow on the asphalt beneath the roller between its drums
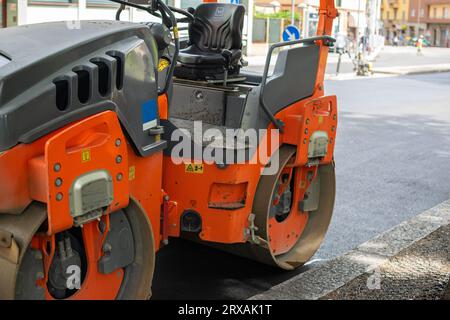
[[152, 239, 310, 300]]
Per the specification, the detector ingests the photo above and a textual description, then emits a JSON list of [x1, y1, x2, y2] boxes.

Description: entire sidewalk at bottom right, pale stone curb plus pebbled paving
[[250, 200, 450, 300]]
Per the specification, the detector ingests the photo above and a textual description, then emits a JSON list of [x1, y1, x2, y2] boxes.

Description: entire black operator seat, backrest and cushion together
[[175, 3, 245, 80]]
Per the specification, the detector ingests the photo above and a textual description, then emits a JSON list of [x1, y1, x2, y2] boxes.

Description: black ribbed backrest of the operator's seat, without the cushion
[[189, 3, 245, 52]]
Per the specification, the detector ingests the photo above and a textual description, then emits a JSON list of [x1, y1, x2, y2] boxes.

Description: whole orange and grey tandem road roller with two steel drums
[[0, 0, 337, 300]]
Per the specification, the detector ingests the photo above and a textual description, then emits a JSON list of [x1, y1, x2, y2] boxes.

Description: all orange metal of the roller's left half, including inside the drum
[[0, 110, 163, 299]]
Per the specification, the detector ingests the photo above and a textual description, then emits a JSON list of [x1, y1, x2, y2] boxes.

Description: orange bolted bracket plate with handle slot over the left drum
[[28, 111, 129, 234]]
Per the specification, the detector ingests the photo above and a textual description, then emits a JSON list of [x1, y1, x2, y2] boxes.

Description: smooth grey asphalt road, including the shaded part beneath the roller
[[153, 73, 450, 299]]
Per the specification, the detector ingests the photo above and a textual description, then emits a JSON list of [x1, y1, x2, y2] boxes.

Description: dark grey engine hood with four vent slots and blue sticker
[[0, 21, 165, 156]]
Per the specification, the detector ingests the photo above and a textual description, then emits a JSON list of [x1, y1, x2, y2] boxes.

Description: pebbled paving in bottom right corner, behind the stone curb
[[321, 225, 450, 300]]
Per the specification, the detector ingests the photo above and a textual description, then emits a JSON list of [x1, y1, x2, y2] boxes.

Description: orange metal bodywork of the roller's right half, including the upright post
[[163, 0, 337, 245]]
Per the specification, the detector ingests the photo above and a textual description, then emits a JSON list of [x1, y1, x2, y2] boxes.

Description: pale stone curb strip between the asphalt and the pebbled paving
[[249, 200, 450, 300]]
